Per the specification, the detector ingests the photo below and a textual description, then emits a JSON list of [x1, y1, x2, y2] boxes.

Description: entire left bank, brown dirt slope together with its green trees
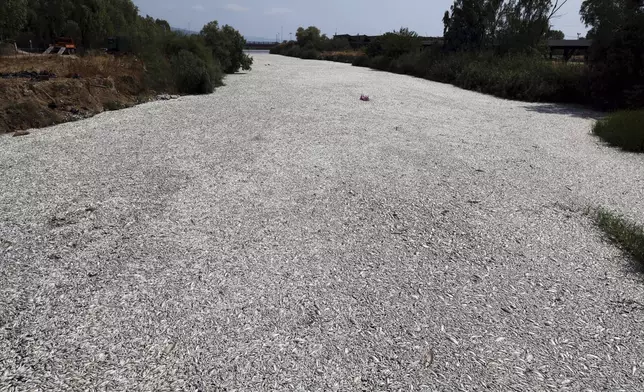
[[0, 0, 252, 133]]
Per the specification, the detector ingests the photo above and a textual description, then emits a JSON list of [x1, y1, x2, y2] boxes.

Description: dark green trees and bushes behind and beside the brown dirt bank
[[0, 0, 252, 93]]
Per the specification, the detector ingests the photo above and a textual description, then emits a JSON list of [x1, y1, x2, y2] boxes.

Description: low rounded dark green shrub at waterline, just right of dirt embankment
[[170, 49, 215, 94]]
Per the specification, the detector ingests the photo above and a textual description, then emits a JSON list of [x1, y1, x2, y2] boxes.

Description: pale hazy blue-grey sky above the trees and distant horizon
[[134, 0, 586, 39]]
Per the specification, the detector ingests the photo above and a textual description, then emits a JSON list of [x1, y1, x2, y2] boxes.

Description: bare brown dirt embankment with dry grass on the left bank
[[0, 55, 151, 133]]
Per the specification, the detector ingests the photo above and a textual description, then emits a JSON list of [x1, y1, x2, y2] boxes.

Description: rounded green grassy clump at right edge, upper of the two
[[593, 110, 644, 152]]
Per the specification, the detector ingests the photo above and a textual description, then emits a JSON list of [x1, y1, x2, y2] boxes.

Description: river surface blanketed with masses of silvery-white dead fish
[[0, 55, 644, 391]]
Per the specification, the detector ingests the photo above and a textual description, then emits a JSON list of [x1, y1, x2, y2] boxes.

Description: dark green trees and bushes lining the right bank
[[272, 0, 644, 110]]
